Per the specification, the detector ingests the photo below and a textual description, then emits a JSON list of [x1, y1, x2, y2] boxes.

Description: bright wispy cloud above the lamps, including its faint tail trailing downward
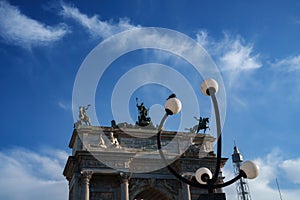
[[196, 30, 262, 109]]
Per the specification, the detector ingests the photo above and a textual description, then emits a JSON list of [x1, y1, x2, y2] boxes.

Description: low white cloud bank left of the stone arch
[[0, 148, 68, 200]]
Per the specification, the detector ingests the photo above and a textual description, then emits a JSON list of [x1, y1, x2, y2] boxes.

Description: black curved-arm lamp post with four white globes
[[157, 78, 259, 199]]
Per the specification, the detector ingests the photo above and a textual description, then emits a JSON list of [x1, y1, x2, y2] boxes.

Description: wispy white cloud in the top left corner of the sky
[[0, 1, 68, 48]]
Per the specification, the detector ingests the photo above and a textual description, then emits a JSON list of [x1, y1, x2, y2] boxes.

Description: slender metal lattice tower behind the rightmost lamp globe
[[232, 145, 251, 200]]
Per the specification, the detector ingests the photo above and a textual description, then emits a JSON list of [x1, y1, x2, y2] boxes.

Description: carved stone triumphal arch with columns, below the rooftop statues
[[63, 126, 227, 200]]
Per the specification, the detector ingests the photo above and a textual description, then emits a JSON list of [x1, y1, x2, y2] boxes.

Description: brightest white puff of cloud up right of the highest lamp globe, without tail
[[196, 30, 262, 72]]
